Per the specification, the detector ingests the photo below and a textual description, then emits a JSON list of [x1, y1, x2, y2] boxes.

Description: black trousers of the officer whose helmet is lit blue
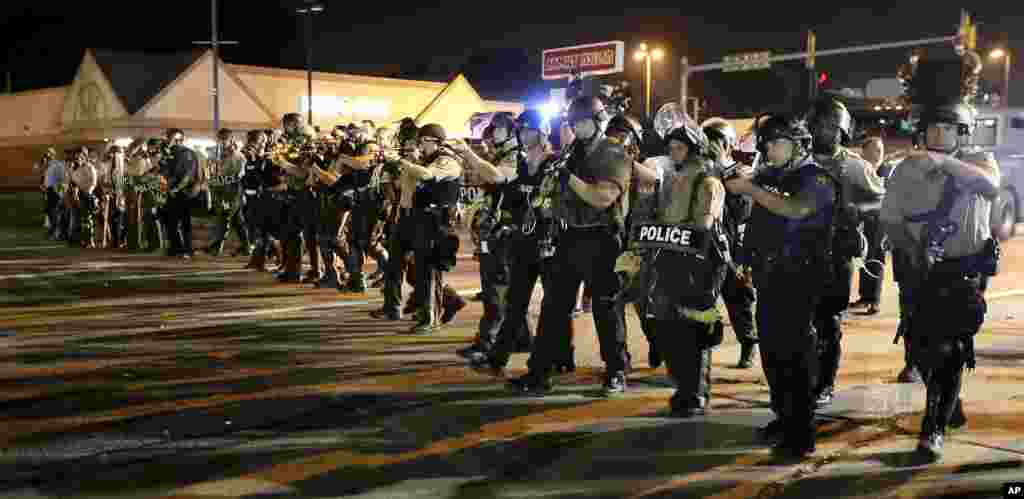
[[489, 237, 548, 367]]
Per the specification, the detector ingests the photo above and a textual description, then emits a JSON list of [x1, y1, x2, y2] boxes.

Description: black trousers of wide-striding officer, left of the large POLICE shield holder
[[527, 227, 630, 376]]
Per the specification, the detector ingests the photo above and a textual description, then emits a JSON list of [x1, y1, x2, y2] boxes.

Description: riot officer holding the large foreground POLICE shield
[[616, 117, 730, 417]]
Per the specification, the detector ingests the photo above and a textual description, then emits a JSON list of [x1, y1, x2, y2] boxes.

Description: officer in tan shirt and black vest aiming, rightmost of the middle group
[[386, 123, 462, 334]]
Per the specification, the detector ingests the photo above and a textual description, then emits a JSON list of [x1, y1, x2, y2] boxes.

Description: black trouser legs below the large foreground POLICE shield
[[653, 320, 714, 410]]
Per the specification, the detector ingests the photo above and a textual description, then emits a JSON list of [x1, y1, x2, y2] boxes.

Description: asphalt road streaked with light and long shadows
[[0, 231, 1024, 498]]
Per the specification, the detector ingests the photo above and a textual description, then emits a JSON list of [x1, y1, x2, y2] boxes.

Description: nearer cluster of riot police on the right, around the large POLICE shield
[[452, 52, 998, 459]]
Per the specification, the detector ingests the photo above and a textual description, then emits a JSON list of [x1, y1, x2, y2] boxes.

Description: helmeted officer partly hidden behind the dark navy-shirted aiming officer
[[807, 97, 885, 405]]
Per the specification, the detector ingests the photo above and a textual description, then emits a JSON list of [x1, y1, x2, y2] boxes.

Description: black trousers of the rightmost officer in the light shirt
[[908, 271, 987, 435]]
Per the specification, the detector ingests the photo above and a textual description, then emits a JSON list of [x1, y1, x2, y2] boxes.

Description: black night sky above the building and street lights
[[0, 0, 1024, 116]]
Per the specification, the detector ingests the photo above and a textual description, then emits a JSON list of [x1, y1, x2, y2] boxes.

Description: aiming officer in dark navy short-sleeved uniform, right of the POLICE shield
[[726, 115, 837, 457]]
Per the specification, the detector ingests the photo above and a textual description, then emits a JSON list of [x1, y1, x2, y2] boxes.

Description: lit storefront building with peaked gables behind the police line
[[0, 49, 522, 189]]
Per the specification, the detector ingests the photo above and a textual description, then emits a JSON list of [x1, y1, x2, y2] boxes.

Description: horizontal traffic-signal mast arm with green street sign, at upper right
[[679, 11, 977, 112]]
